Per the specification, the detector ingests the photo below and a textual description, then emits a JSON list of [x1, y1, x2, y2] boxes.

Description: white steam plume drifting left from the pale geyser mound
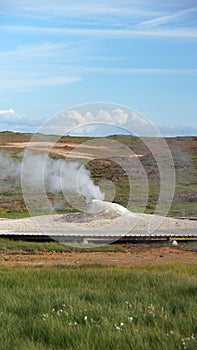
[[0, 152, 104, 203]]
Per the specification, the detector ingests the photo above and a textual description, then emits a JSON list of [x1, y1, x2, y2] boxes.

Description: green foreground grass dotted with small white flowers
[[0, 264, 197, 350]]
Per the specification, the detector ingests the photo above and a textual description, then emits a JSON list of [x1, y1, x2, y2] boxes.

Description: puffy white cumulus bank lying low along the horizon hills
[[0, 107, 197, 137]]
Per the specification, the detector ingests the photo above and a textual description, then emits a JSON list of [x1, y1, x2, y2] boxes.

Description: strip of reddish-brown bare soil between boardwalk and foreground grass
[[0, 243, 197, 267]]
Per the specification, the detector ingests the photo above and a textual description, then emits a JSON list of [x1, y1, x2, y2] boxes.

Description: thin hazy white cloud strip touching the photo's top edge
[[2, 0, 159, 18]]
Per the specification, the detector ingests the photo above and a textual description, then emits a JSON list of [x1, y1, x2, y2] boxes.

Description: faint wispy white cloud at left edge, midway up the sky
[[0, 40, 86, 91]]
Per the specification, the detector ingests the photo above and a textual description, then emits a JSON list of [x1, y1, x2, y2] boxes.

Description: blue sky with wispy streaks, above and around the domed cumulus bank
[[0, 0, 197, 136]]
